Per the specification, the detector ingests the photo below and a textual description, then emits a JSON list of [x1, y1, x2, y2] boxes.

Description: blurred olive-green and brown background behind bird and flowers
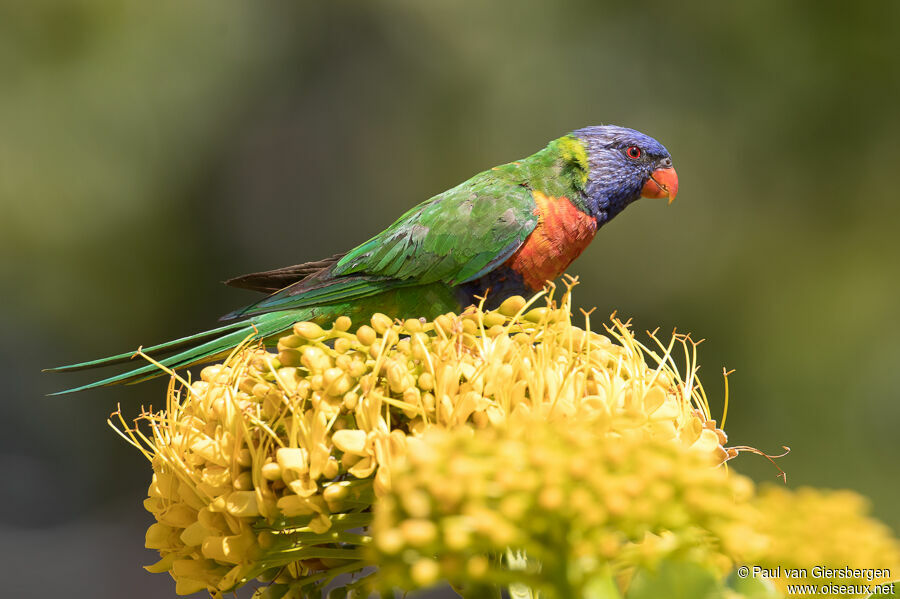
[[0, 0, 900, 598]]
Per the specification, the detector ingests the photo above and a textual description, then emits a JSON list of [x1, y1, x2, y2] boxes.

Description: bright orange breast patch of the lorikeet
[[506, 191, 597, 290]]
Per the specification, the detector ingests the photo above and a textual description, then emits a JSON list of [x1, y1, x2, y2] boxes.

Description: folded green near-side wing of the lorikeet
[[228, 168, 538, 318]]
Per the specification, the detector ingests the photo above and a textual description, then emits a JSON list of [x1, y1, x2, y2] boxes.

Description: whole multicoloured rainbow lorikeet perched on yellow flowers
[[51, 125, 678, 393]]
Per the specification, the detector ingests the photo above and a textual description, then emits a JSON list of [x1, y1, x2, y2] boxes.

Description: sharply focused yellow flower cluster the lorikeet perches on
[[118, 293, 734, 597]]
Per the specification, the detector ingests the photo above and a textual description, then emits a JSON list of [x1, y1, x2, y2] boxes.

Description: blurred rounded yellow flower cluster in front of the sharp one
[[370, 415, 752, 599]]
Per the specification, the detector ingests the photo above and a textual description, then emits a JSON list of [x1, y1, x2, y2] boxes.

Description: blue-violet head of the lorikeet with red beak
[[572, 125, 678, 223]]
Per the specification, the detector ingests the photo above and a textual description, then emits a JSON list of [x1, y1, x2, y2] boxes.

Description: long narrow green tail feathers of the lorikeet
[[45, 310, 304, 395]]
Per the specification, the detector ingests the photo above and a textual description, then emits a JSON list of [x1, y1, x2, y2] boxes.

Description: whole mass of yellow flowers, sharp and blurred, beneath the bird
[[117, 284, 900, 599]]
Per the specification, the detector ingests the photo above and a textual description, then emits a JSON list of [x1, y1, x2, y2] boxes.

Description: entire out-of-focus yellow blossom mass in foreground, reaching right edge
[[368, 415, 900, 599]]
